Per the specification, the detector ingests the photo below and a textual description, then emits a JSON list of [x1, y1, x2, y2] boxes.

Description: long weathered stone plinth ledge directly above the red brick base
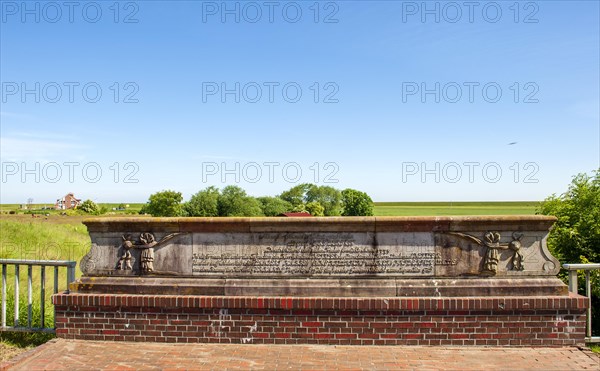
[[71, 277, 568, 297]]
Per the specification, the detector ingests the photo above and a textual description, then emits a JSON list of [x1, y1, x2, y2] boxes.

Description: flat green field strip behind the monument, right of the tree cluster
[[374, 201, 539, 216]]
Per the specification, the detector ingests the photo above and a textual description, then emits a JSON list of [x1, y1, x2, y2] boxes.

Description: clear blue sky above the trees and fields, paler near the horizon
[[0, 1, 600, 203]]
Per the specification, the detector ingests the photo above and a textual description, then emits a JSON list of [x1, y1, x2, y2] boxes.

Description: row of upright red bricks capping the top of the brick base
[[52, 292, 589, 313]]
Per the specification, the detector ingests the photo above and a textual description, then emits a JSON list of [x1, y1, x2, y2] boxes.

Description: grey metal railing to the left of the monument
[[0, 259, 77, 333]]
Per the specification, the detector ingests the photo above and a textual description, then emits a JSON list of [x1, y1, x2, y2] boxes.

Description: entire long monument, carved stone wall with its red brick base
[[54, 216, 587, 346]]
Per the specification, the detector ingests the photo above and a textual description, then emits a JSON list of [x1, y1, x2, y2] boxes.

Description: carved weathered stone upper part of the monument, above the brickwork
[[74, 216, 566, 296]]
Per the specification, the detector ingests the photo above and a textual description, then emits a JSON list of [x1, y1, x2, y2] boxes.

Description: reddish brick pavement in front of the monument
[[0, 339, 600, 371]]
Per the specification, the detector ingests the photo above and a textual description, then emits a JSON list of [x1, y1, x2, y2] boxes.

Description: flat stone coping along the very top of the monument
[[83, 215, 557, 232]]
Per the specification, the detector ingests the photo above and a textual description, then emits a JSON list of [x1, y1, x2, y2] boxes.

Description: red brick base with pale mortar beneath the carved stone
[[53, 293, 588, 346]]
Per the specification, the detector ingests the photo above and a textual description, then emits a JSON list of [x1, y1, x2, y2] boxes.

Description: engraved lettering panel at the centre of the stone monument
[[191, 233, 456, 276]]
